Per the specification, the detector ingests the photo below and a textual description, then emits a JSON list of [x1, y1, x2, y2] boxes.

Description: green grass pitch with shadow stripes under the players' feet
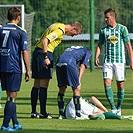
[[0, 69, 133, 133]]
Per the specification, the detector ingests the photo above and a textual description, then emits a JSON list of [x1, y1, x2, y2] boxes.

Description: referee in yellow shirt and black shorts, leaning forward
[[31, 22, 82, 119]]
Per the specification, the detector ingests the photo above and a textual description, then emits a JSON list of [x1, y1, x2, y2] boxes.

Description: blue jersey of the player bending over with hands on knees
[[57, 46, 92, 68]]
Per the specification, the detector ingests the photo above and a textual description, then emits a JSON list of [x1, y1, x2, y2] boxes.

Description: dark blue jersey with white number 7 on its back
[[0, 23, 27, 73]]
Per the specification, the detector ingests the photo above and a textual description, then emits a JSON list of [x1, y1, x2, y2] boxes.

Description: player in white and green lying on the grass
[[65, 96, 121, 120]]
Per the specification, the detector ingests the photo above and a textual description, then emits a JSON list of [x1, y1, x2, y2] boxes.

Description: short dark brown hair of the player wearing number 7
[[7, 7, 21, 21]]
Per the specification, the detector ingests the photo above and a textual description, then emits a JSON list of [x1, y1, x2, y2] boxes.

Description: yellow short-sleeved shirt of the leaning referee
[[35, 23, 65, 53]]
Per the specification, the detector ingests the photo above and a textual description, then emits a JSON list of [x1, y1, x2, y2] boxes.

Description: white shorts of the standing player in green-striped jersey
[[103, 63, 125, 81]]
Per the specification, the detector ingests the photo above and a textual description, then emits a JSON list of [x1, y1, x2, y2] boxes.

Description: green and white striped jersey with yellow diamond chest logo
[[98, 24, 130, 63]]
